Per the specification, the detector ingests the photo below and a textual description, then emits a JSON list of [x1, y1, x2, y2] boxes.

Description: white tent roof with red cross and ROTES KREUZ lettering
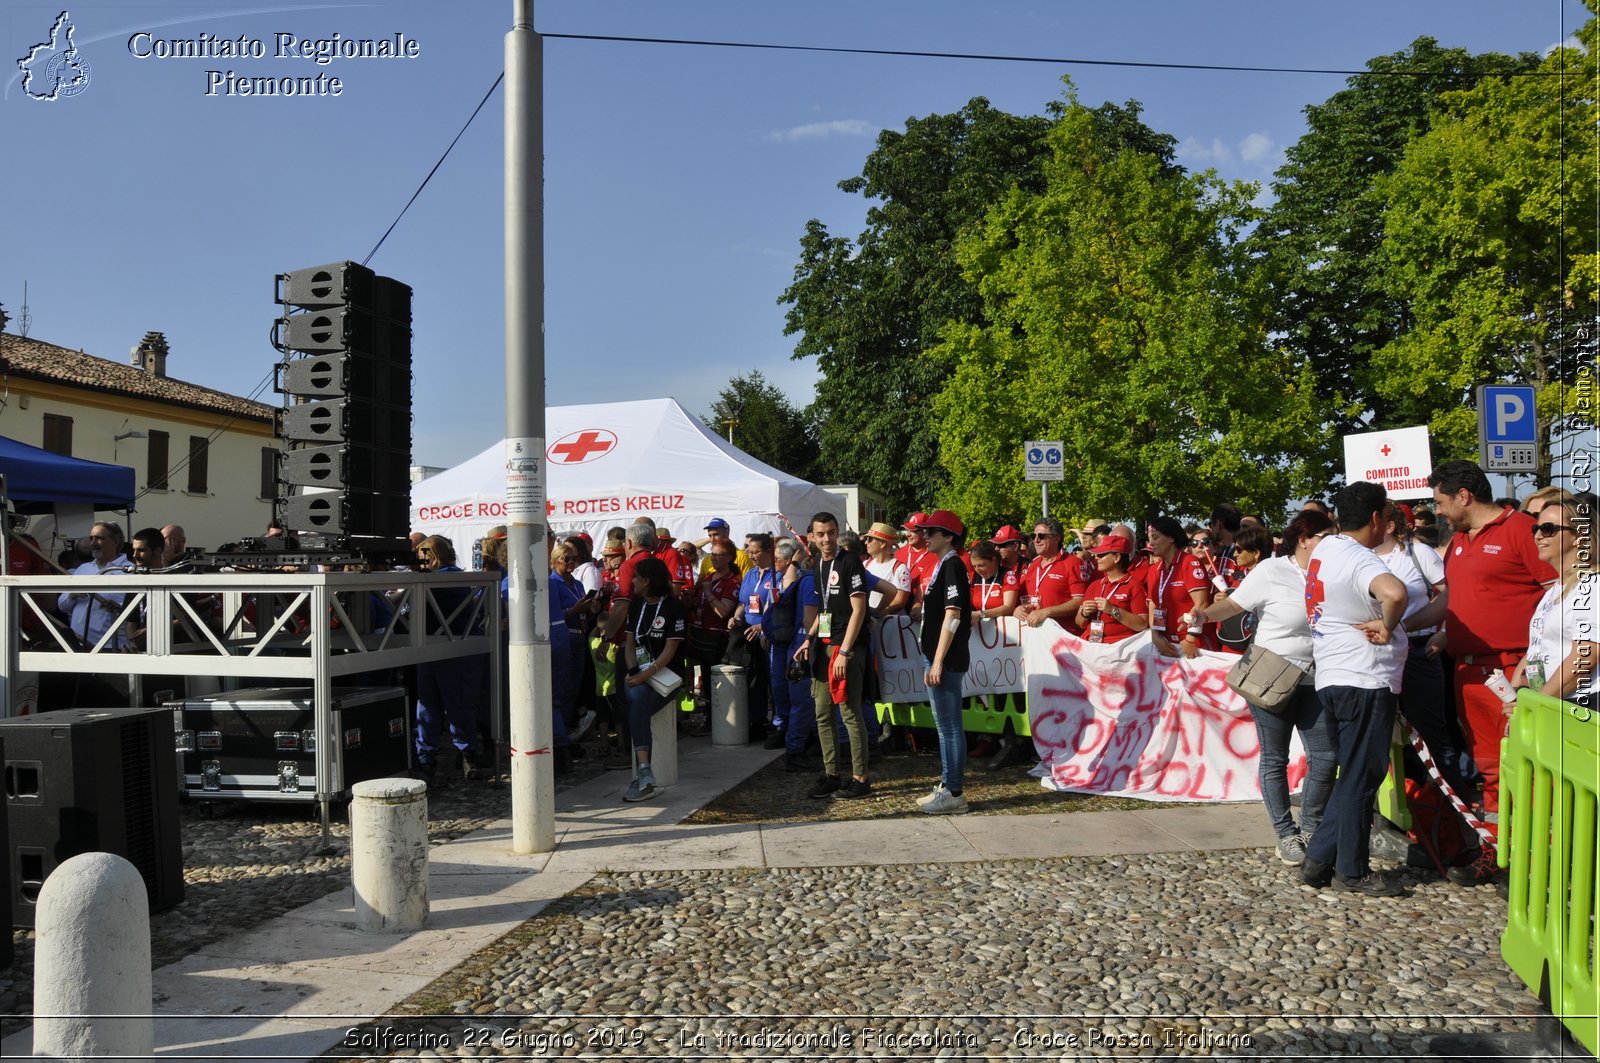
[[411, 399, 848, 547]]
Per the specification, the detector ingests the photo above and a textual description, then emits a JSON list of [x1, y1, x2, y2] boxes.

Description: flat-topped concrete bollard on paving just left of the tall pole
[[350, 778, 427, 933]]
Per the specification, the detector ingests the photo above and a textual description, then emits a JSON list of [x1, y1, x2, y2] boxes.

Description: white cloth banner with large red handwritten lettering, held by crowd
[[1022, 623, 1306, 802]]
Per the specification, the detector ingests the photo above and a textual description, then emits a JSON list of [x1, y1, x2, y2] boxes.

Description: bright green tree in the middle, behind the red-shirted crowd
[[933, 90, 1325, 527]]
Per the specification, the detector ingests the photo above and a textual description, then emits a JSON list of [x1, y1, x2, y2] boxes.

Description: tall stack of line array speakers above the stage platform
[[274, 263, 411, 552]]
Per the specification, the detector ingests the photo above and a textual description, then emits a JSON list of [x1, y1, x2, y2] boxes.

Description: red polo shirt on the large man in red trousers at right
[[1445, 506, 1557, 658]]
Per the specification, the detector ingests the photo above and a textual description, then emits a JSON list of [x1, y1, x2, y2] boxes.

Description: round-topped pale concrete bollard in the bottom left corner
[[34, 853, 155, 1060]]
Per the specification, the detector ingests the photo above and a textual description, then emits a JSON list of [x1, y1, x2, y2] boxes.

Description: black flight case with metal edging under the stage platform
[[170, 687, 411, 802]]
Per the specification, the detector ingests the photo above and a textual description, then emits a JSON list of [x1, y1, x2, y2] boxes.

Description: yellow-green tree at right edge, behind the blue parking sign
[[1373, 19, 1600, 475]]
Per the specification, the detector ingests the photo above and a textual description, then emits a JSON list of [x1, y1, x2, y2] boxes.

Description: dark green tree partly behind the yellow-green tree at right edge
[[1250, 37, 1538, 477]]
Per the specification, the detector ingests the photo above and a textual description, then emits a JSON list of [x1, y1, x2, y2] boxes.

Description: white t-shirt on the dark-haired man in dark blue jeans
[[1306, 535, 1408, 693]]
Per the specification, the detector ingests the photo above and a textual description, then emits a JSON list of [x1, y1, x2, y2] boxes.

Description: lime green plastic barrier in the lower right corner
[[1496, 688, 1600, 1053]]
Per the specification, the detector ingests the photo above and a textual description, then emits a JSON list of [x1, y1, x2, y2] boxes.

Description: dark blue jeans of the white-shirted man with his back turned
[[1306, 687, 1395, 879]]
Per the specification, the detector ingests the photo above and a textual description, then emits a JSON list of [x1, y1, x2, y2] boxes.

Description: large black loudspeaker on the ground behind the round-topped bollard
[[0, 708, 184, 927]]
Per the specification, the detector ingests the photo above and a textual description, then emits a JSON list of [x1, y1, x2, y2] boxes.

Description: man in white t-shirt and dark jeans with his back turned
[[1301, 482, 1406, 897]]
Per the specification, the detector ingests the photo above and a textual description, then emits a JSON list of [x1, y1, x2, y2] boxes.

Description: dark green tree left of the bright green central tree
[[779, 98, 1174, 512]]
